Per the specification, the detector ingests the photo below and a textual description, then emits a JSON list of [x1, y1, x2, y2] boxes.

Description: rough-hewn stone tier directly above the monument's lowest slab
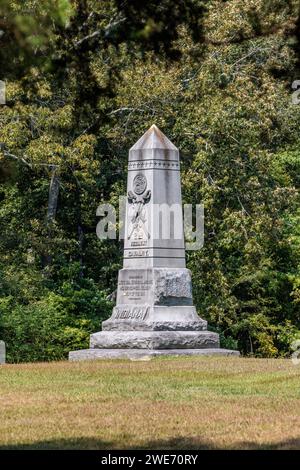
[[90, 331, 219, 349]]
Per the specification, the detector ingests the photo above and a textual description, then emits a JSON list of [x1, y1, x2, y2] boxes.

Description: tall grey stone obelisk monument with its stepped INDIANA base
[[69, 125, 239, 360]]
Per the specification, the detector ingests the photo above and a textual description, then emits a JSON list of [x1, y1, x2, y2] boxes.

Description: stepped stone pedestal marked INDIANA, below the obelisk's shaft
[[69, 268, 239, 360]]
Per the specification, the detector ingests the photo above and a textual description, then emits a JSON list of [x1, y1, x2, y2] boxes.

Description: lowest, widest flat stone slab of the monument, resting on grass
[[69, 348, 240, 361]]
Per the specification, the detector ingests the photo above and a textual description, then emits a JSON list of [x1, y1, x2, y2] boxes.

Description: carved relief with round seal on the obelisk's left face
[[128, 173, 151, 239]]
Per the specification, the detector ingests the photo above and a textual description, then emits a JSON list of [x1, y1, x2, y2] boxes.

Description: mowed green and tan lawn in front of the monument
[[0, 357, 300, 449]]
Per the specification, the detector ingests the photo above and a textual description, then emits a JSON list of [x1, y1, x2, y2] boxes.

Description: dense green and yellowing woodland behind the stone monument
[[0, 0, 300, 362]]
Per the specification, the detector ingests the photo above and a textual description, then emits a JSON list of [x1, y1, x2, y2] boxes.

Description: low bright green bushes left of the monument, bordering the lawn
[[1, 294, 88, 362]]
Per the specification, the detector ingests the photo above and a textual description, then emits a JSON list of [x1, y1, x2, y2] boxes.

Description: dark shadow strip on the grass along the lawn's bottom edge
[[0, 436, 300, 450]]
